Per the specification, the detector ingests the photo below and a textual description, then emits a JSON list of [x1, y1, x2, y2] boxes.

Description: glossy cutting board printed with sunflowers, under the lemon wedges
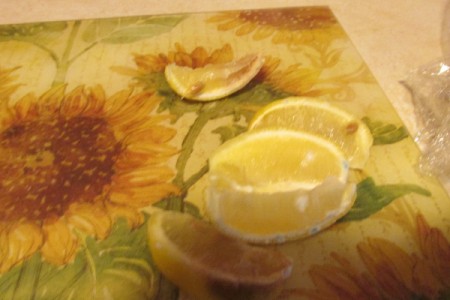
[[0, 7, 450, 299]]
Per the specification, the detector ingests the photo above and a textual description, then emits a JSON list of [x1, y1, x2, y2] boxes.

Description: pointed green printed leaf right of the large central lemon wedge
[[339, 177, 431, 222]]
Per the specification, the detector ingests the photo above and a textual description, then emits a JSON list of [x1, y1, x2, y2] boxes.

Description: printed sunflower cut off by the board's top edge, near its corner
[[208, 7, 344, 50]]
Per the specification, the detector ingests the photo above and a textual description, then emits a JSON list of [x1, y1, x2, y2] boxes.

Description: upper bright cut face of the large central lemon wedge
[[209, 129, 348, 192]]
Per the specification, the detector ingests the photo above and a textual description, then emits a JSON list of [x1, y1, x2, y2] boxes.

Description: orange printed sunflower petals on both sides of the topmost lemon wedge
[[125, 43, 374, 101]]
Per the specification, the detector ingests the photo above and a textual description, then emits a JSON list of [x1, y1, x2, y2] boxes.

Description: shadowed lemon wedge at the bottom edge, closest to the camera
[[148, 211, 292, 299]]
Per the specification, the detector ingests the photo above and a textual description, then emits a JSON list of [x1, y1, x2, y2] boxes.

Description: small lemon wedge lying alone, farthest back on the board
[[164, 55, 264, 101]]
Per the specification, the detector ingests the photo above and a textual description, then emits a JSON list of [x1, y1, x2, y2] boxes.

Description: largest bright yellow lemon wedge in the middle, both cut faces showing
[[205, 129, 355, 244]]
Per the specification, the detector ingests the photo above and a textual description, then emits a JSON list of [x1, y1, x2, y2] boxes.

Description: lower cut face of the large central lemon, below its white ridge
[[206, 176, 355, 244]]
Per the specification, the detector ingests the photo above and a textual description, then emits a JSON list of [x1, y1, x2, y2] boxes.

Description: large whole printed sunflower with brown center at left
[[0, 86, 178, 273]]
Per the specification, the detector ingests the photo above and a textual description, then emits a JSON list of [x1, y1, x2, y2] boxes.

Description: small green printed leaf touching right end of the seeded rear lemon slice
[[362, 117, 409, 145]]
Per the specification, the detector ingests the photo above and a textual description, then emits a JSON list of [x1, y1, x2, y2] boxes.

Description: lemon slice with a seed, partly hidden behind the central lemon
[[249, 97, 373, 169]]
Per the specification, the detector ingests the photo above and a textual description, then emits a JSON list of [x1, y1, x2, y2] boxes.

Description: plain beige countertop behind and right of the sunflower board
[[0, 0, 446, 190]]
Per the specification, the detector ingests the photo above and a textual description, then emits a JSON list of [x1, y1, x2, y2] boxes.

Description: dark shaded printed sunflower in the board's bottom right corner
[[285, 214, 450, 300]]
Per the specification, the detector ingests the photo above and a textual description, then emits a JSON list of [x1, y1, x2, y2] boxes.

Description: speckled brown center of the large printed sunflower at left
[[0, 116, 122, 222]]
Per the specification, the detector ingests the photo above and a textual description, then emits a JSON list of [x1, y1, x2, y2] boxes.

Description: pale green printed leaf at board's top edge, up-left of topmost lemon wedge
[[82, 15, 184, 44]]
